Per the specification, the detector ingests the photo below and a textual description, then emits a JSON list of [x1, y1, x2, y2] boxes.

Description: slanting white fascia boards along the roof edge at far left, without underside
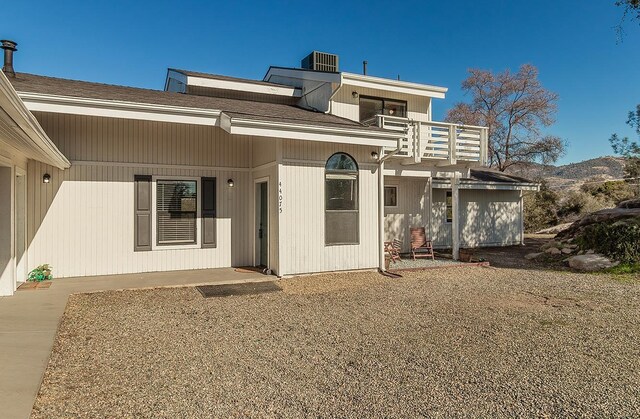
[[0, 71, 71, 169]]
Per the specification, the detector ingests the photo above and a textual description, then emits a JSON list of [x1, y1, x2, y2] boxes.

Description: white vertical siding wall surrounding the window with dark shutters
[[27, 113, 254, 277]]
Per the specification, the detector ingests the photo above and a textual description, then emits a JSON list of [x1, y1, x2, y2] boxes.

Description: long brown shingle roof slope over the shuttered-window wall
[[10, 73, 380, 130]]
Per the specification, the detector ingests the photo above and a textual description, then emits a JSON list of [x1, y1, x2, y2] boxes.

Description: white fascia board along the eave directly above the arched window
[[223, 118, 398, 147]]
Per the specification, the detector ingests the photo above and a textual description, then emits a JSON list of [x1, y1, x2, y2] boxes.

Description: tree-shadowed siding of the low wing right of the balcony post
[[432, 189, 520, 247]]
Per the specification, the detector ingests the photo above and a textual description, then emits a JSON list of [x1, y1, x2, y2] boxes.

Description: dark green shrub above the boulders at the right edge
[[576, 219, 640, 264]]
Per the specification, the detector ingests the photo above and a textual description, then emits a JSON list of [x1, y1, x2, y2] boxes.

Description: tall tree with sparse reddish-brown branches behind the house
[[446, 64, 565, 172]]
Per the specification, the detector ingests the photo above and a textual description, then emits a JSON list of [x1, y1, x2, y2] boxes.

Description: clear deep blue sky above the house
[[5, 0, 640, 163]]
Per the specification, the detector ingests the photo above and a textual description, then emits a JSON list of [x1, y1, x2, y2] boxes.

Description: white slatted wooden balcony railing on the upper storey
[[376, 115, 488, 166]]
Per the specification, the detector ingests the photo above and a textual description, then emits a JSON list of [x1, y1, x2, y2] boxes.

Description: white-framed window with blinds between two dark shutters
[[156, 180, 198, 245]]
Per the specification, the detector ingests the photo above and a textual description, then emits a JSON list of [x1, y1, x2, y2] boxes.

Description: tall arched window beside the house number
[[324, 153, 360, 245]]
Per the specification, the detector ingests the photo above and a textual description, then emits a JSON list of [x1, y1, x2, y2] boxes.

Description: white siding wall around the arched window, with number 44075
[[278, 140, 378, 275]]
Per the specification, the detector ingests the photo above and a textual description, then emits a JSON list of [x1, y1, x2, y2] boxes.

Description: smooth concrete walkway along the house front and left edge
[[0, 268, 266, 419]]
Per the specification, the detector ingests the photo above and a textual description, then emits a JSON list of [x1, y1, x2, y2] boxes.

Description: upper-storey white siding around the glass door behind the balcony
[[331, 85, 431, 121]]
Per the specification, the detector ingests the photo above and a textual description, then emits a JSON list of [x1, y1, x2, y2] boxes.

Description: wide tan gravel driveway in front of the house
[[33, 267, 640, 418]]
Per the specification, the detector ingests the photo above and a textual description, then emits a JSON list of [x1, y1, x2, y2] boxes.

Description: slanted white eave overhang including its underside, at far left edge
[[0, 71, 71, 169]]
